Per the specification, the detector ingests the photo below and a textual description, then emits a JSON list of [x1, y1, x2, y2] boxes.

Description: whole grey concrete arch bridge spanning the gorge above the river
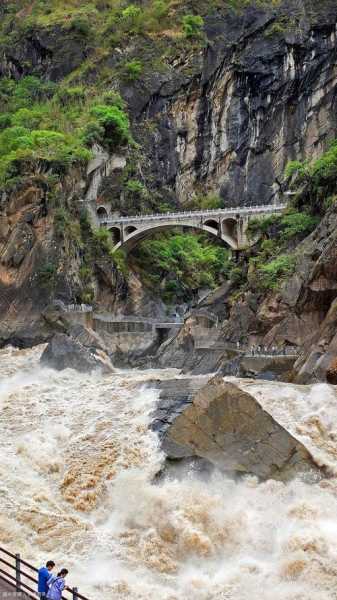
[[97, 204, 286, 251]]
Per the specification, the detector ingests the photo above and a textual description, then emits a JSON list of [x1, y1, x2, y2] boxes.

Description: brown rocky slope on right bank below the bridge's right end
[[158, 207, 337, 383]]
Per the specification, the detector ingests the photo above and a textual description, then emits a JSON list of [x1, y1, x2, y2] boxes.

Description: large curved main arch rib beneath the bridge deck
[[114, 221, 237, 250]]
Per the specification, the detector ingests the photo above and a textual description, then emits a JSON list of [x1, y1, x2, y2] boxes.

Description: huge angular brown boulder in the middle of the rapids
[[155, 377, 318, 479]]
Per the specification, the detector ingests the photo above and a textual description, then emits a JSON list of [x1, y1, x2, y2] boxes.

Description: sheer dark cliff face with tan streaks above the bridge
[[124, 1, 337, 206]]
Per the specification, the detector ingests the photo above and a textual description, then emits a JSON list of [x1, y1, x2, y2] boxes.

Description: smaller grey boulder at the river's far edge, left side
[[41, 333, 114, 373]]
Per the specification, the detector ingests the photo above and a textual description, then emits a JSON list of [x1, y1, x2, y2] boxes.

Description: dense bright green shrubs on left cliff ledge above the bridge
[[0, 76, 132, 185]]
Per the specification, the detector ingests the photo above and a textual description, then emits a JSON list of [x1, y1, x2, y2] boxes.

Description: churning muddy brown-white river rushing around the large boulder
[[0, 348, 337, 600]]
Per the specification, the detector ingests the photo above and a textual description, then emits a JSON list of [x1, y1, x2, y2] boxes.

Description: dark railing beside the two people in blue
[[0, 546, 88, 600]]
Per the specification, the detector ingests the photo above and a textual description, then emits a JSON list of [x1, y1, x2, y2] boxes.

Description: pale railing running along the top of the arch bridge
[[99, 204, 287, 225]]
